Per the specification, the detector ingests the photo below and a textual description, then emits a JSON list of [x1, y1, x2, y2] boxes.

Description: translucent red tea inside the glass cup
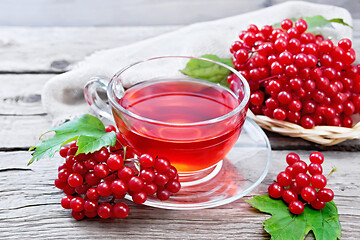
[[113, 79, 246, 173]]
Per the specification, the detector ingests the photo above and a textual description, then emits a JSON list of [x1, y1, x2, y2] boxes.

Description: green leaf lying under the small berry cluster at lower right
[[246, 194, 341, 240]]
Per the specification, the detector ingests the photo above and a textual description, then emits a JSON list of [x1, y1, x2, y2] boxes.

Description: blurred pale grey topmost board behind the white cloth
[[0, 0, 360, 26]]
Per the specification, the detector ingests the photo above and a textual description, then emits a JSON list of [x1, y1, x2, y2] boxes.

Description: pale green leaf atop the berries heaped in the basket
[[273, 15, 351, 33]]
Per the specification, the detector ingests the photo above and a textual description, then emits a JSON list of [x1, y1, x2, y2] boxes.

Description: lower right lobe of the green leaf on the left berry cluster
[[76, 132, 116, 154]]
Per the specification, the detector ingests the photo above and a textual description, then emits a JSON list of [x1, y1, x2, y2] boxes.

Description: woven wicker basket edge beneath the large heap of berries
[[247, 110, 360, 146]]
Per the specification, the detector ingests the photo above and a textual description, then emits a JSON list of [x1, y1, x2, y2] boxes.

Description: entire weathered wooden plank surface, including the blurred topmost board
[[0, 0, 360, 240]]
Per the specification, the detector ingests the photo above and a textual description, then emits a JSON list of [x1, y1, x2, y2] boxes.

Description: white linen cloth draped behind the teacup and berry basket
[[42, 1, 352, 125]]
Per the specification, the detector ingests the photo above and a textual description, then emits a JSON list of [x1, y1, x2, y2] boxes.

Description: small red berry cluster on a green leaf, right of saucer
[[268, 152, 334, 214]]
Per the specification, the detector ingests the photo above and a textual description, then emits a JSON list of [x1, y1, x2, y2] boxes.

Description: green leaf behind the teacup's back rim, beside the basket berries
[[180, 54, 234, 87]]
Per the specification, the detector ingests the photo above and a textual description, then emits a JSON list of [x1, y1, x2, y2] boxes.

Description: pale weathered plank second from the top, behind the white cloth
[[0, 19, 360, 73]]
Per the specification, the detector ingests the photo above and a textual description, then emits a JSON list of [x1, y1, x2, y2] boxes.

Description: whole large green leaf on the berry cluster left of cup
[[28, 114, 116, 165]]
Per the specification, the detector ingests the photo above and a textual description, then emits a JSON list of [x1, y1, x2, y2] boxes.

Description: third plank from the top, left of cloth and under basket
[[0, 74, 360, 151]]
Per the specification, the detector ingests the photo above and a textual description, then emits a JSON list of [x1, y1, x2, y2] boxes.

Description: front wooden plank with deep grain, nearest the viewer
[[0, 151, 360, 239]]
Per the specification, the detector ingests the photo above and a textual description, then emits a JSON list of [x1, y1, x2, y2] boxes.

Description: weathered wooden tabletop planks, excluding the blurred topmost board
[[0, 7, 360, 239]]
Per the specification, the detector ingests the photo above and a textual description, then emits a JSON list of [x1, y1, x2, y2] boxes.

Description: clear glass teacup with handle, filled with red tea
[[85, 56, 250, 183]]
